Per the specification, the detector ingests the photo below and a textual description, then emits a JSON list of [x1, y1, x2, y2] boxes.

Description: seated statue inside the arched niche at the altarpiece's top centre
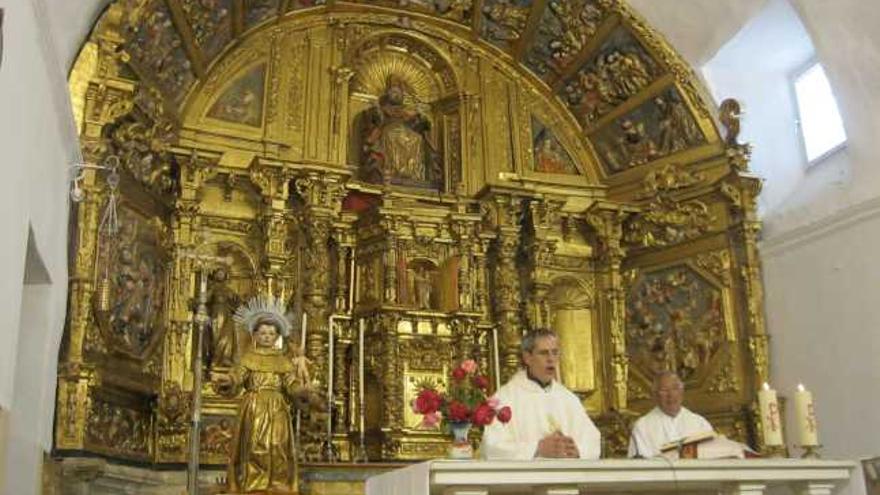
[[362, 75, 441, 185]]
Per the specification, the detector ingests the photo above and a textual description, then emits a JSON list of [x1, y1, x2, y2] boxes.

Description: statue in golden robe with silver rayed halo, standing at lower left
[[212, 298, 316, 494]]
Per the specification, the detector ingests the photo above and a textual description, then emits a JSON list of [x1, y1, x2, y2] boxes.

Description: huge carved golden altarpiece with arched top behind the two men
[[55, 0, 768, 488]]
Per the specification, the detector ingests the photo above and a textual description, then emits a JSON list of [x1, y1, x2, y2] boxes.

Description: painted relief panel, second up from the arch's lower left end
[[180, 0, 232, 60]]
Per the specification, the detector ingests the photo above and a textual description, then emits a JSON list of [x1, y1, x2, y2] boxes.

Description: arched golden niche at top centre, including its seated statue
[[345, 33, 461, 191]]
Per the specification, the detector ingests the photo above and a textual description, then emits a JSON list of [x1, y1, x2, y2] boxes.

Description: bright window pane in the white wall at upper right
[[795, 64, 846, 162]]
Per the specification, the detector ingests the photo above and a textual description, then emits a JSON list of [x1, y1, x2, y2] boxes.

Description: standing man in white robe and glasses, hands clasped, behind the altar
[[482, 329, 600, 460]]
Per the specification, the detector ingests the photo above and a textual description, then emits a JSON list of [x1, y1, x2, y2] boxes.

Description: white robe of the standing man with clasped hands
[[482, 370, 601, 460]]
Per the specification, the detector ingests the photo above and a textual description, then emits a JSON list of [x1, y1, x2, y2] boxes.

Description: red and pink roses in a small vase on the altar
[[412, 359, 512, 459]]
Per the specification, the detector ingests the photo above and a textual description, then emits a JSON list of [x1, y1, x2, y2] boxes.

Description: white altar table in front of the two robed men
[[366, 459, 855, 495]]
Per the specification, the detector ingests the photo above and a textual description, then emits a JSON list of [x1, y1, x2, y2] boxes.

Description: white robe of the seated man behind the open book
[[629, 407, 713, 458]]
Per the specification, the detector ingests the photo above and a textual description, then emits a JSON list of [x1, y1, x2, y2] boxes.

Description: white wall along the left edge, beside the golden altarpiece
[[0, 0, 78, 494]]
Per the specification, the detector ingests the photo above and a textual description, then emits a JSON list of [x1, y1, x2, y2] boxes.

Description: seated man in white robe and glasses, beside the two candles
[[629, 371, 713, 458]]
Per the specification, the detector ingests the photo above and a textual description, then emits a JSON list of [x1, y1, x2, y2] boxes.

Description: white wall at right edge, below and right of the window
[[763, 0, 880, 464]]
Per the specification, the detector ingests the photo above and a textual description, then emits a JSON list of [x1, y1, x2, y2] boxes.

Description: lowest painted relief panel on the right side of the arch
[[592, 88, 706, 174]]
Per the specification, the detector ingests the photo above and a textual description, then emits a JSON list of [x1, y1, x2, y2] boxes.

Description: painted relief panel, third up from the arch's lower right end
[[525, 0, 609, 76]]
